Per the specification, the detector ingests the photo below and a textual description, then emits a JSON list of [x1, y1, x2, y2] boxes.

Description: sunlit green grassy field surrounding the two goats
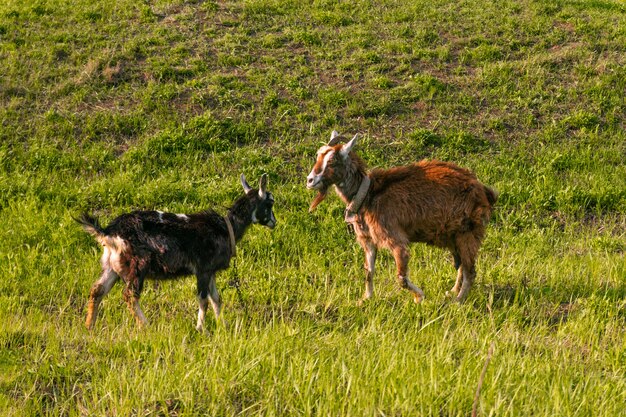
[[0, 0, 626, 416]]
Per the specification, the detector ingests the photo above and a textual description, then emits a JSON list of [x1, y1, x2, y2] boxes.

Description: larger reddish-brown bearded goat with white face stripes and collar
[[307, 131, 498, 303]]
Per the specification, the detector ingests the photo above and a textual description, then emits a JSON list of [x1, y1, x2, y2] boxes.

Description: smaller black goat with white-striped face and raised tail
[[75, 174, 276, 330]]
